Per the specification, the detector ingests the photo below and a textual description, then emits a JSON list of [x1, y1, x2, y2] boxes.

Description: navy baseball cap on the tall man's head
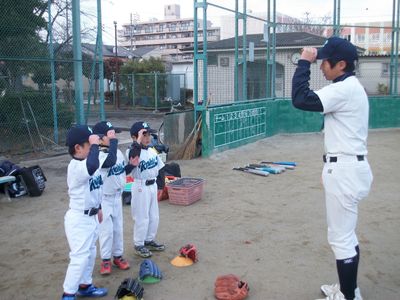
[[317, 36, 358, 62]]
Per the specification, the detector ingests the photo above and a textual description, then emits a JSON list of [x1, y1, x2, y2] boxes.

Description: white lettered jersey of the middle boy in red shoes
[[99, 149, 126, 195]]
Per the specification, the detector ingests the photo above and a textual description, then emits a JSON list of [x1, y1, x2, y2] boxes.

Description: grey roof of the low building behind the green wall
[[185, 32, 326, 50]]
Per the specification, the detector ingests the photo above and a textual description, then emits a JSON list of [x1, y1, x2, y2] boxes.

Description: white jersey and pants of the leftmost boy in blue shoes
[[63, 154, 104, 294]]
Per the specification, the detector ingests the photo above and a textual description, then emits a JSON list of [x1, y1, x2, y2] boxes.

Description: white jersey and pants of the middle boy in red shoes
[[99, 150, 126, 259]]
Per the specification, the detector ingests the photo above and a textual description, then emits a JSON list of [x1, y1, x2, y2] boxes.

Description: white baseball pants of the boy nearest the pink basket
[[131, 178, 160, 246]]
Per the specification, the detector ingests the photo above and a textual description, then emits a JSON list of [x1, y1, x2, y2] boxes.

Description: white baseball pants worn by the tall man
[[322, 156, 373, 260]]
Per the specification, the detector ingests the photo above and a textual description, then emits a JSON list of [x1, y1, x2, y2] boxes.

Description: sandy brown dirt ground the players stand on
[[0, 129, 400, 300]]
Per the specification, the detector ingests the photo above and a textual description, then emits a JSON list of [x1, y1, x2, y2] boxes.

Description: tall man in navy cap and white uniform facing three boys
[[292, 37, 372, 300]]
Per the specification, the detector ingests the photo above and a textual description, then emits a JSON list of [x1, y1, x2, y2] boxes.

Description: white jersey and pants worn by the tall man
[[315, 76, 373, 260]]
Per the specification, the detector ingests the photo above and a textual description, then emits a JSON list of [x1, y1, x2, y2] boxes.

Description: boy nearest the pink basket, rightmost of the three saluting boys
[[126, 122, 165, 258]]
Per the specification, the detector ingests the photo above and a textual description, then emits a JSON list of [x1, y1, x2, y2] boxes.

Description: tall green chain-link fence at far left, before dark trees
[[0, 0, 104, 153]]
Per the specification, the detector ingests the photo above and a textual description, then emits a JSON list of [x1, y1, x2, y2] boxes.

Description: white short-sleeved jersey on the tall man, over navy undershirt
[[315, 76, 369, 155]]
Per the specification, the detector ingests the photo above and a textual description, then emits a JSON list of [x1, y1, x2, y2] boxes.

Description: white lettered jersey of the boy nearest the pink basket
[[126, 148, 164, 180]]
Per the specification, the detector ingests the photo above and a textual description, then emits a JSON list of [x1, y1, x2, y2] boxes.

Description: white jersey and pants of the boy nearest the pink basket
[[126, 148, 164, 246]]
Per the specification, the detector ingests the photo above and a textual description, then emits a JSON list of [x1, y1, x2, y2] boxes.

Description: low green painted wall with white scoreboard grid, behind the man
[[203, 97, 400, 156]]
